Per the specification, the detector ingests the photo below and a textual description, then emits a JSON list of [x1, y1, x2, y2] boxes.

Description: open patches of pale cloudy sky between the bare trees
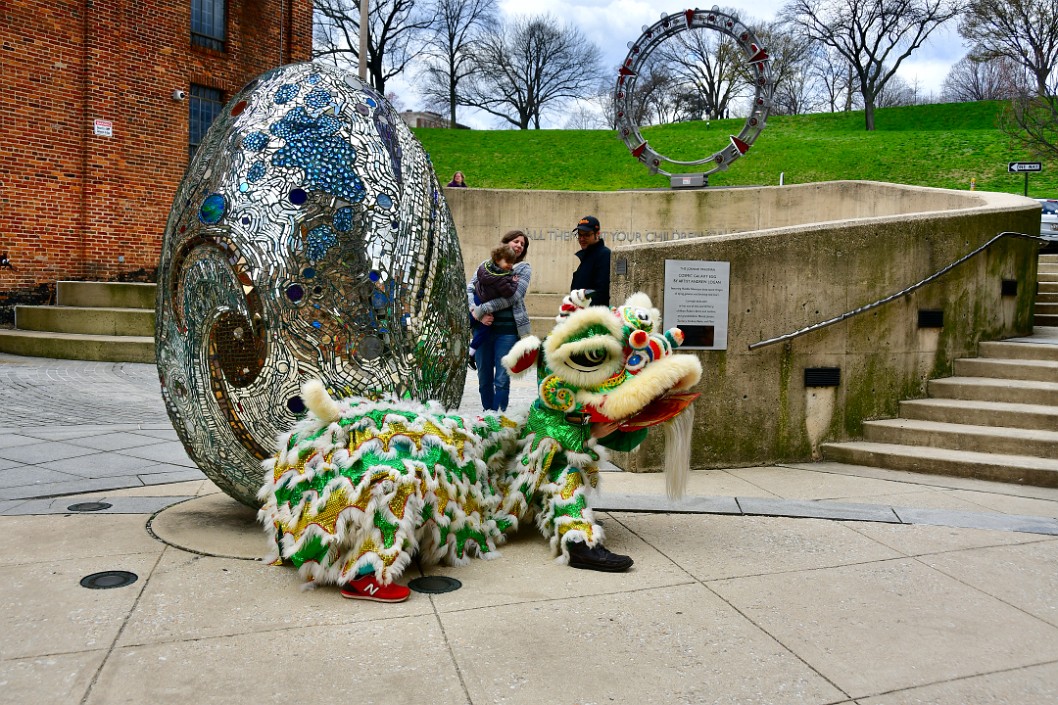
[[395, 0, 967, 129]]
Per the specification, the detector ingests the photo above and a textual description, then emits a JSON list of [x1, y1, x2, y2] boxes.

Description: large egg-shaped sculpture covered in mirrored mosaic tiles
[[156, 64, 469, 506]]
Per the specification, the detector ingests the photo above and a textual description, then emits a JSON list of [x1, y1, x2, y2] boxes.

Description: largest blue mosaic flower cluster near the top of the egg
[[269, 106, 365, 203]]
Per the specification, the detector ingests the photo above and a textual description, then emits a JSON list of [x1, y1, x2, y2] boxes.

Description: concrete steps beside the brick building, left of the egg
[[0, 282, 156, 362]]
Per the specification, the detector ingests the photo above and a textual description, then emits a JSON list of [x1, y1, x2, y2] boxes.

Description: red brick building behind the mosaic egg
[[0, 0, 312, 304]]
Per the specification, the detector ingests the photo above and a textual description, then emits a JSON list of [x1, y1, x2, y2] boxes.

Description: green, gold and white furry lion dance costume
[[259, 291, 701, 585]]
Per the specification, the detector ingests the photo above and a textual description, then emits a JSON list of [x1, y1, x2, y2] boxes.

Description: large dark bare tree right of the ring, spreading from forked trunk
[[783, 0, 959, 130]]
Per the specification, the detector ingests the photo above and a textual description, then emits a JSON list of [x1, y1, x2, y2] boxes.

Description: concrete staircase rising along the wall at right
[[821, 255, 1058, 487]]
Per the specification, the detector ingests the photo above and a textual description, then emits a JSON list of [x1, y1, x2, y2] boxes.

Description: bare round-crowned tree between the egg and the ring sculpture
[[459, 15, 601, 129]]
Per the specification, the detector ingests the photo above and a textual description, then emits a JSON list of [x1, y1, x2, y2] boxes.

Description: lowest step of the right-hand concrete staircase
[[821, 440, 1058, 487]]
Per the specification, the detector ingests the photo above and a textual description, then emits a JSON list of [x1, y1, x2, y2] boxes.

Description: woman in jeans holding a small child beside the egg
[[467, 230, 532, 411]]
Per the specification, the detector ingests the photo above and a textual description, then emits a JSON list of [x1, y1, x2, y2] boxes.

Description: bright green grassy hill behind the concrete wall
[[415, 102, 1058, 198]]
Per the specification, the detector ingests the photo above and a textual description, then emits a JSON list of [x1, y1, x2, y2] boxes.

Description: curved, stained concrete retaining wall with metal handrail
[[446, 182, 1040, 470]]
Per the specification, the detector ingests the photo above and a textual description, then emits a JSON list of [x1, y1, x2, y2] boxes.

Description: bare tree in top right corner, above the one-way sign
[[959, 0, 1058, 96]]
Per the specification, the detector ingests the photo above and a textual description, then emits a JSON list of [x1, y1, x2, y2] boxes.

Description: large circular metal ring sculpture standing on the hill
[[614, 5, 771, 177]]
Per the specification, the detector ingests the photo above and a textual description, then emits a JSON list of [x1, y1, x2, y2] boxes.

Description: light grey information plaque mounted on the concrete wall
[[662, 259, 731, 350]]
